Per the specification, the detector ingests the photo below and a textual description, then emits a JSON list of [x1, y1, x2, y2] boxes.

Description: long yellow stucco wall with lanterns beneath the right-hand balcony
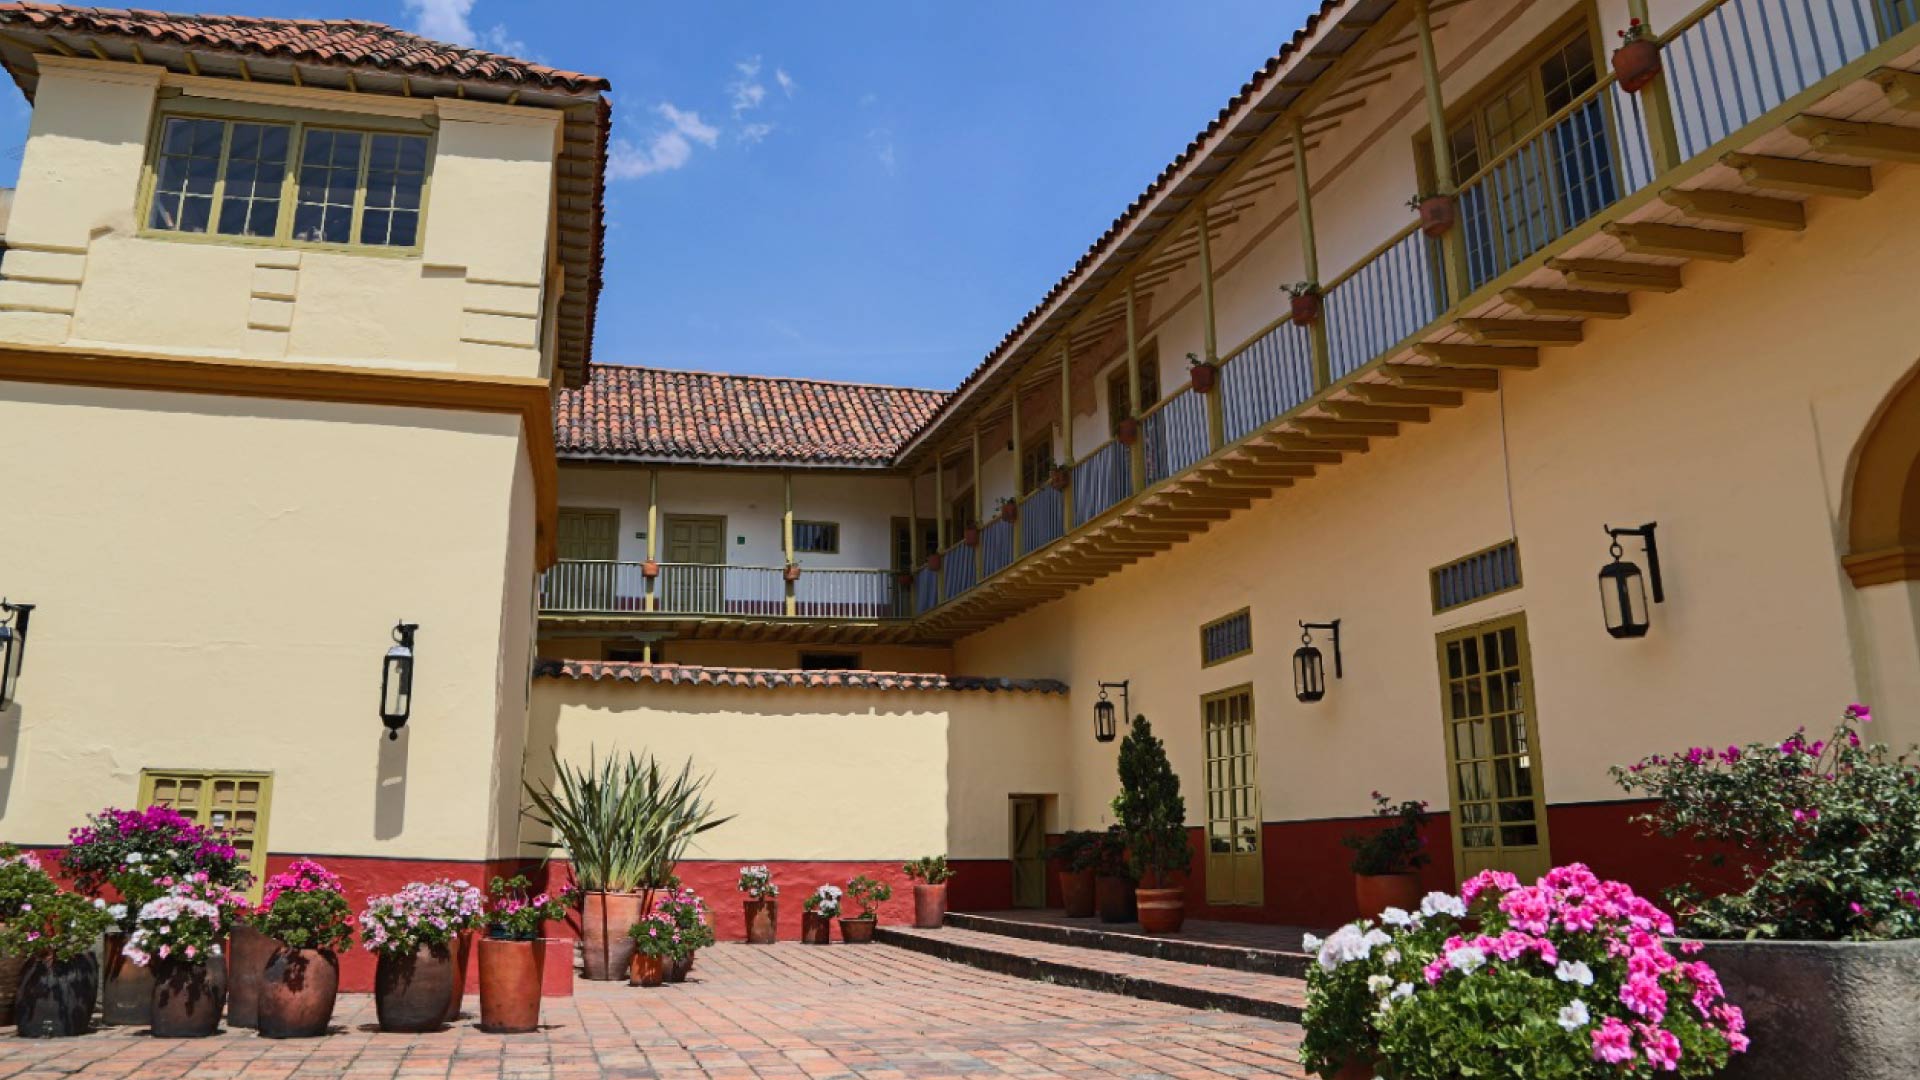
[[956, 169, 1920, 826]]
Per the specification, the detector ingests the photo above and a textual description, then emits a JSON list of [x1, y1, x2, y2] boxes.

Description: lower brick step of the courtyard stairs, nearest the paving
[[876, 926, 1306, 1022]]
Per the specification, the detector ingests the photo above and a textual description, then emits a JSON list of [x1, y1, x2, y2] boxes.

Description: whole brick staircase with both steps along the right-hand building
[[877, 911, 1311, 1022]]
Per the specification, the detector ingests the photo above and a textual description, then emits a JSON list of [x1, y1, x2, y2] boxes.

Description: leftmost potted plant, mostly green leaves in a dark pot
[[0, 855, 113, 1038]]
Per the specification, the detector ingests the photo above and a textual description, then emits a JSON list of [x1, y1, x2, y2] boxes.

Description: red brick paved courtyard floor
[[0, 944, 1306, 1080]]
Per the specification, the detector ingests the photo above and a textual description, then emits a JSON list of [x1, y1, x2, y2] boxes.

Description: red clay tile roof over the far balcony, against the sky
[[553, 363, 947, 465]]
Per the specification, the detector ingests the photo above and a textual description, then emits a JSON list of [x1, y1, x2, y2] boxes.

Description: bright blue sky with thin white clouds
[[0, 0, 1309, 388]]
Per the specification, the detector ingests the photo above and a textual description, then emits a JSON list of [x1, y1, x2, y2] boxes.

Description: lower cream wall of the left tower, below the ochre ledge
[[0, 382, 534, 859]]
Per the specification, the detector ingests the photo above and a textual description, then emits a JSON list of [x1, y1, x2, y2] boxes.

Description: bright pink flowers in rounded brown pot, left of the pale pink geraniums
[[253, 859, 353, 1040]]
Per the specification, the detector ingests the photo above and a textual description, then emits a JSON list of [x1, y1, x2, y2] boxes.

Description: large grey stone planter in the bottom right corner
[[1695, 930, 1920, 1080]]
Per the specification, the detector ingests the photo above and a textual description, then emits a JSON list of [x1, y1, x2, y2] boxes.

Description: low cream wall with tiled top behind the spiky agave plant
[[526, 678, 1069, 861]]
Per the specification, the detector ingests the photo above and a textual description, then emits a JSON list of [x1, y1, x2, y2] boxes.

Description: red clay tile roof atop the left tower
[[0, 4, 609, 92]]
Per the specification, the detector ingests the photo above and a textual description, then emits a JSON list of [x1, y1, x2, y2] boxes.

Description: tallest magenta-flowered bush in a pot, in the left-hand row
[[60, 807, 248, 1024]]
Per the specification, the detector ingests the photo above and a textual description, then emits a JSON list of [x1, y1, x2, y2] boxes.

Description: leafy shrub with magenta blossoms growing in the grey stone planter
[[1613, 705, 1920, 942]]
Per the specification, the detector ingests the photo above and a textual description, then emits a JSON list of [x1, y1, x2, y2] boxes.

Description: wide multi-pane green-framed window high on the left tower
[[138, 100, 434, 256]]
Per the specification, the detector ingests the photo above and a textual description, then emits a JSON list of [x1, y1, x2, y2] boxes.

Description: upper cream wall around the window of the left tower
[[0, 56, 559, 375]]
